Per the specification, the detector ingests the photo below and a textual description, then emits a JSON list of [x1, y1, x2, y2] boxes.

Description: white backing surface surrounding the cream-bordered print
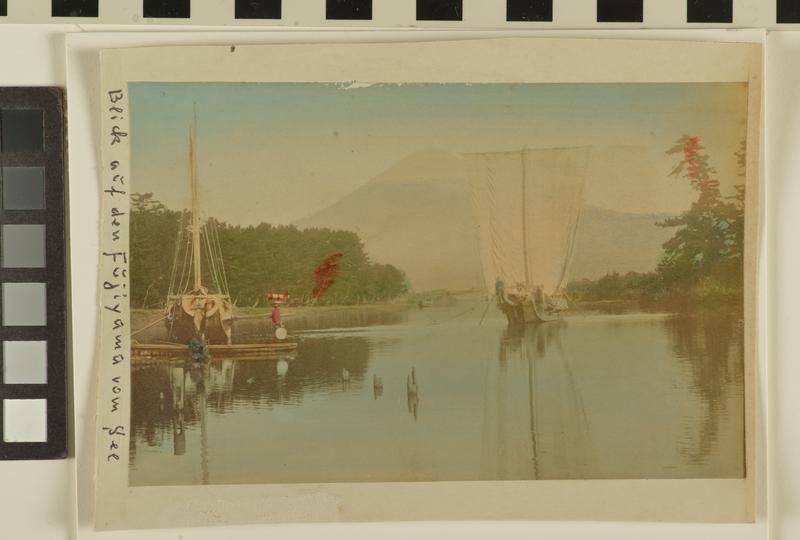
[[0, 24, 800, 540]]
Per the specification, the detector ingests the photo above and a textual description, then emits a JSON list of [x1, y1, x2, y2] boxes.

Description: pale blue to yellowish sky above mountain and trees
[[130, 83, 747, 224]]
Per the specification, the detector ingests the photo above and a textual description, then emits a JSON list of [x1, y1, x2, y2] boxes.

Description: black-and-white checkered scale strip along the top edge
[[0, 0, 800, 29]]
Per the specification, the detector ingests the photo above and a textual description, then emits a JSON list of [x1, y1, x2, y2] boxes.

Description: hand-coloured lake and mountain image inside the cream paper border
[[128, 82, 750, 486]]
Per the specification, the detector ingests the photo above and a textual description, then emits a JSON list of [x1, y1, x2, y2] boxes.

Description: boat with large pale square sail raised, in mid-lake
[[465, 147, 590, 324]]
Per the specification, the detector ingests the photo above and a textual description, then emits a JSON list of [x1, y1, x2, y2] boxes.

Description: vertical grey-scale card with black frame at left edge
[[0, 87, 67, 459]]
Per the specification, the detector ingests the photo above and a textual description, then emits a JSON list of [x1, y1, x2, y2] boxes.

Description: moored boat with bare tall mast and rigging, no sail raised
[[165, 112, 233, 345]]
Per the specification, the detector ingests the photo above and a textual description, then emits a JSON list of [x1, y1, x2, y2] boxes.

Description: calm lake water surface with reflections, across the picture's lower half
[[130, 300, 744, 485]]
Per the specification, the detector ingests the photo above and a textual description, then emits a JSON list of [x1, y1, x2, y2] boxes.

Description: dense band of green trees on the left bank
[[131, 193, 408, 307]]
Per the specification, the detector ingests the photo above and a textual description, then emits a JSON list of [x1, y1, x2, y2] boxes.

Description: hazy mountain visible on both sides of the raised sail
[[295, 149, 671, 291]]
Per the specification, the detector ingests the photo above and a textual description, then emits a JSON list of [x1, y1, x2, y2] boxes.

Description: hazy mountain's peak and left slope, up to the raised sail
[[295, 149, 482, 291]]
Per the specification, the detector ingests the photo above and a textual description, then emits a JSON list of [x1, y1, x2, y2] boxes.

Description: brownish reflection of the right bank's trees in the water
[[666, 312, 744, 470]]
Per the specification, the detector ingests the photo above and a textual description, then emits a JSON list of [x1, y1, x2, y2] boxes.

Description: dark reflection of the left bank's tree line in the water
[[130, 337, 370, 461]]
